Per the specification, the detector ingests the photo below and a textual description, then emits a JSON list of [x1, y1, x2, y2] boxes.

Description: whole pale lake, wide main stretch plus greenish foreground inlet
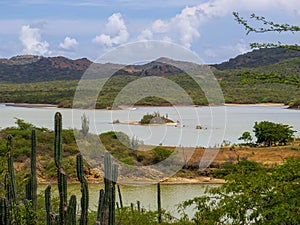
[[0, 105, 300, 216]]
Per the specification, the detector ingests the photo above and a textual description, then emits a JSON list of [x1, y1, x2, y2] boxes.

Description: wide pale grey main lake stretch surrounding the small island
[[0, 105, 300, 147]]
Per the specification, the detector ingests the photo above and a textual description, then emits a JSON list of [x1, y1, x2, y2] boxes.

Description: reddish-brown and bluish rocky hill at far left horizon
[[0, 55, 92, 83]]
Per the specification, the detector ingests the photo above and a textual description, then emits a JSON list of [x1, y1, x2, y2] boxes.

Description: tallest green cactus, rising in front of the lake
[[54, 112, 68, 225]]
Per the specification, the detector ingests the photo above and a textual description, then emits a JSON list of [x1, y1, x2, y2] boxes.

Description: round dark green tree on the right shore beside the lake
[[253, 121, 296, 146]]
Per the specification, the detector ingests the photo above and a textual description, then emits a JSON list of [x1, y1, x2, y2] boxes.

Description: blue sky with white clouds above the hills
[[0, 0, 300, 64]]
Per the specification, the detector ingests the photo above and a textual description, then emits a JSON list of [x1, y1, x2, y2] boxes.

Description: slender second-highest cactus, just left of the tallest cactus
[[26, 130, 37, 210]]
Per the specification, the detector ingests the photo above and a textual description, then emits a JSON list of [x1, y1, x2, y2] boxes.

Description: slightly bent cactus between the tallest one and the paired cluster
[[76, 154, 89, 225]]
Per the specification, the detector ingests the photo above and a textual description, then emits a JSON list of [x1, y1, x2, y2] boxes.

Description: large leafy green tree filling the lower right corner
[[181, 157, 300, 225]]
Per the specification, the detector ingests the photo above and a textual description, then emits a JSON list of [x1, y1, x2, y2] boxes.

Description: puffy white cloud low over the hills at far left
[[19, 25, 51, 55]]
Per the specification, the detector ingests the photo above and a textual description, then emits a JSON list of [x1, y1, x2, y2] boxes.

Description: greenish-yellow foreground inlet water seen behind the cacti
[[38, 184, 217, 217]]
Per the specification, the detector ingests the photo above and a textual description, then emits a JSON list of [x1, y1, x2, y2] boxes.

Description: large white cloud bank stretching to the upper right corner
[[138, 0, 300, 48]]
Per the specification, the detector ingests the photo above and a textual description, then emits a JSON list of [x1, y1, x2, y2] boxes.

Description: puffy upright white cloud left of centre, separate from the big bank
[[93, 13, 129, 47]]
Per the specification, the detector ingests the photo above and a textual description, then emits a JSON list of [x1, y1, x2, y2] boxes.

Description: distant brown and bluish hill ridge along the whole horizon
[[0, 48, 300, 83]]
